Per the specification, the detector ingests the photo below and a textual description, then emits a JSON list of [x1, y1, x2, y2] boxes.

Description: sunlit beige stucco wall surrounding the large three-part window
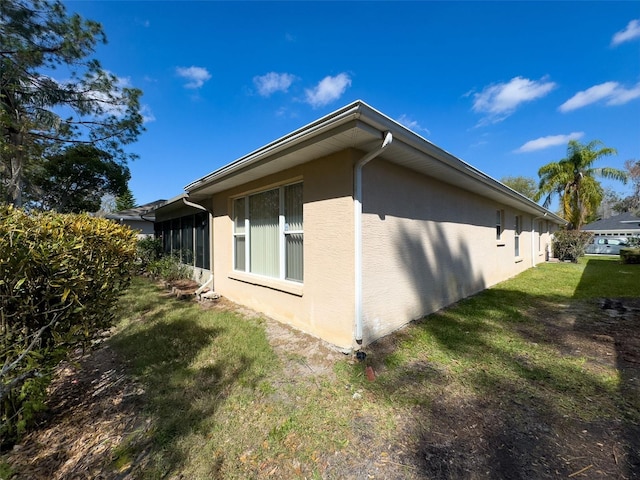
[[212, 150, 354, 348]]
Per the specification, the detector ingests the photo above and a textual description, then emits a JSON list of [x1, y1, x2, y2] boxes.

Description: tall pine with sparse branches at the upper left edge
[[0, 0, 142, 206]]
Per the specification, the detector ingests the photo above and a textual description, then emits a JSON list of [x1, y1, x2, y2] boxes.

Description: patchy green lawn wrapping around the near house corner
[[110, 258, 640, 479]]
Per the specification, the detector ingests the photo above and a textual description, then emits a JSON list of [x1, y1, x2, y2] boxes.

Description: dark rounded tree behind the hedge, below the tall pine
[[31, 145, 131, 213]]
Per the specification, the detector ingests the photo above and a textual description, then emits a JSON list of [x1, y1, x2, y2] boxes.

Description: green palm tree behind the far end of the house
[[534, 140, 627, 230]]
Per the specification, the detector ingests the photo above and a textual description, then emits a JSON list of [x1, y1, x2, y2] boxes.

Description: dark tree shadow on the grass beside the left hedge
[[110, 288, 258, 478]]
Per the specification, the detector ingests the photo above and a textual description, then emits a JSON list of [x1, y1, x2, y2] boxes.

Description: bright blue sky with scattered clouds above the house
[[65, 1, 640, 208]]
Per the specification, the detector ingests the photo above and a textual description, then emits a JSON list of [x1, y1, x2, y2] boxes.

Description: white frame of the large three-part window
[[231, 180, 304, 285]]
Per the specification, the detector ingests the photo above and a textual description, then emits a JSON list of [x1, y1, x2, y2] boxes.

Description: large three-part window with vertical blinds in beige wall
[[233, 183, 304, 282]]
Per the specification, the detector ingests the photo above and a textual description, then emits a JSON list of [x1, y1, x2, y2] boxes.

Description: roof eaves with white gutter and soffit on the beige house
[[185, 100, 567, 224]]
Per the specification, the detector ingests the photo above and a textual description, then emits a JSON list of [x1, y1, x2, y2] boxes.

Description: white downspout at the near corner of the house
[[353, 132, 393, 345]]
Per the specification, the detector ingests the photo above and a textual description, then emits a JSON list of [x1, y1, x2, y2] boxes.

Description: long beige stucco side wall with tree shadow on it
[[363, 159, 548, 344]]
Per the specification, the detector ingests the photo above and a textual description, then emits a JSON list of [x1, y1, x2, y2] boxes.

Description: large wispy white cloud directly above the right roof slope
[[467, 77, 556, 124]]
